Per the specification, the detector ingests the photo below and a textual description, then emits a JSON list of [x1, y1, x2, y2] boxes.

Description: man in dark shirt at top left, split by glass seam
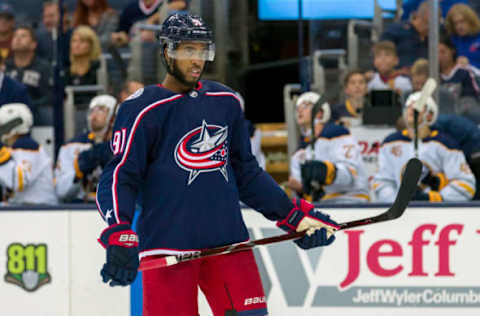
[[36, 0, 72, 65]]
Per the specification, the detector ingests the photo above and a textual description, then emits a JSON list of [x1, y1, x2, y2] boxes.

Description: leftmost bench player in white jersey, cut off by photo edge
[[0, 103, 57, 204]]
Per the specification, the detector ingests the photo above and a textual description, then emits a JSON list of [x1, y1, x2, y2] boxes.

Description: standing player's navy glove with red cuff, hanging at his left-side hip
[[98, 223, 139, 286]]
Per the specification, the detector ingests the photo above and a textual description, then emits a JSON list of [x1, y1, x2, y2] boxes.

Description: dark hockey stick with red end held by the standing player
[[139, 158, 422, 271]]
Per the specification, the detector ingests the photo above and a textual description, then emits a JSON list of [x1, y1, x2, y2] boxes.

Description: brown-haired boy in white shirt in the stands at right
[[368, 41, 412, 95]]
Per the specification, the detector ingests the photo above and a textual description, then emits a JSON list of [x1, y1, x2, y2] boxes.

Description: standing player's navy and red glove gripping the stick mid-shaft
[[277, 199, 340, 249]]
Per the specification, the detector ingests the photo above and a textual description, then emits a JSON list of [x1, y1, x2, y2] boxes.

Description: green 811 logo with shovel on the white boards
[[5, 243, 51, 292]]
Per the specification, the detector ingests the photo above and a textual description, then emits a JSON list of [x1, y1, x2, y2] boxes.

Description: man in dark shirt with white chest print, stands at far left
[[5, 26, 53, 125]]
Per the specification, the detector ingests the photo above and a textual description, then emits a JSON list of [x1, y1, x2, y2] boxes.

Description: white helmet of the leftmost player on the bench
[[0, 103, 33, 142]]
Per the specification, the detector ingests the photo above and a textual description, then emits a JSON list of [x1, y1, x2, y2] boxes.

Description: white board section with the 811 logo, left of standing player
[[0, 210, 130, 316]]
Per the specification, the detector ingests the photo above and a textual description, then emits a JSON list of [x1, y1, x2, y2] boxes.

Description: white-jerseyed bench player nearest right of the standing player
[[288, 92, 370, 203]]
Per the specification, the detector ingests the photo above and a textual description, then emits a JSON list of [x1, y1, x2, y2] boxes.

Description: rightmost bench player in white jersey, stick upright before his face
[[373, 92, 475, 202]]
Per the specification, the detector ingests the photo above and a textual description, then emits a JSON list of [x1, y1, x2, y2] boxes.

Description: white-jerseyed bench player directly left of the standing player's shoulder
[[55, 94, 117, 203]]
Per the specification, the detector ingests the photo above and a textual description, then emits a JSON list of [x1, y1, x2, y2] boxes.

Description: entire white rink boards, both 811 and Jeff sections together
[[0, 207, 480, 316]]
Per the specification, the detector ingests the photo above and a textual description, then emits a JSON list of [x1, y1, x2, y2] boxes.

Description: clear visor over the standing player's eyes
[[167, 41, 215, 61]]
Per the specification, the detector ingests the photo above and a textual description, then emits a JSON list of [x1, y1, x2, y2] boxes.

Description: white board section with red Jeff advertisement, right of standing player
[[200, 208, 480, 316]]
